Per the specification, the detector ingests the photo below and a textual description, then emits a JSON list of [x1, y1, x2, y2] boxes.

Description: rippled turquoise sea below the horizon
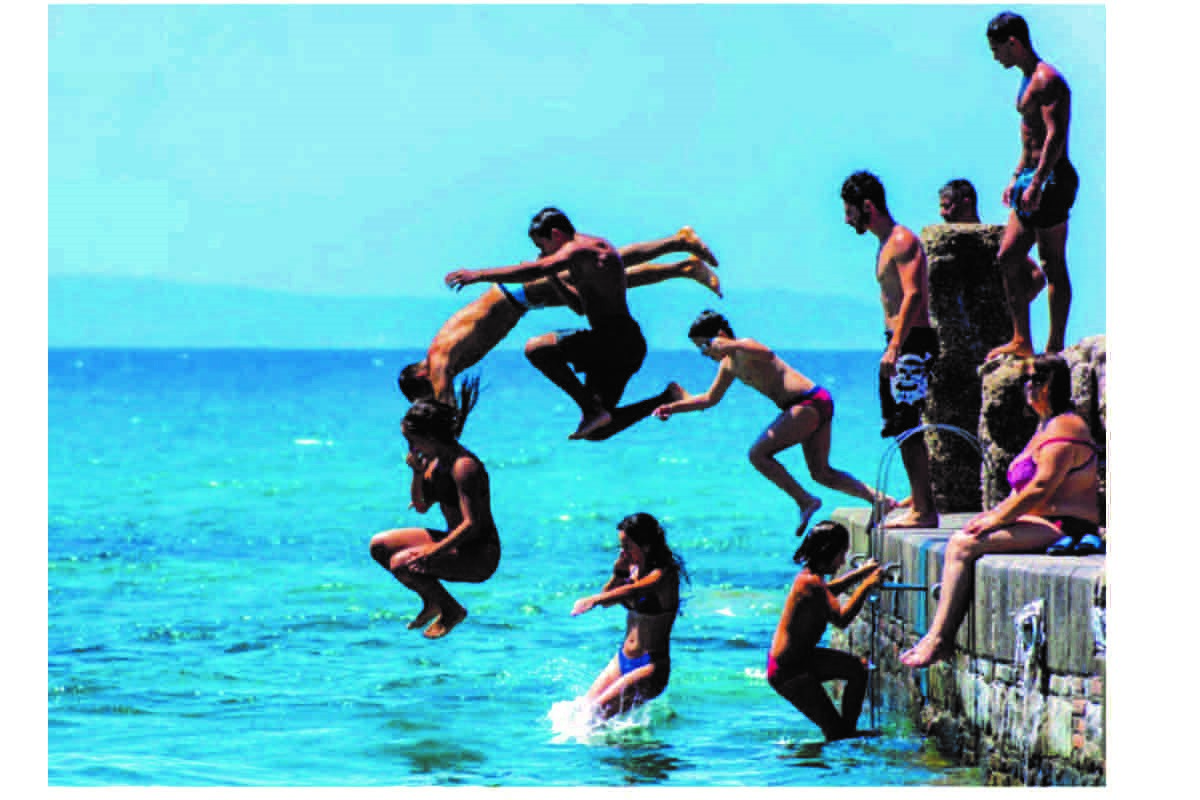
[[47, 350, 979, 787]]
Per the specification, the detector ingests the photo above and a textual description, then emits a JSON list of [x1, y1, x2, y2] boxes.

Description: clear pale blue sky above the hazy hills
[[47, 5, 1108, 341]]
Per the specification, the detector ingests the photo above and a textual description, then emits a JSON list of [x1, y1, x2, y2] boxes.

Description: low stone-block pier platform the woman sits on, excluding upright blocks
[[832, 509, 1106, 786]]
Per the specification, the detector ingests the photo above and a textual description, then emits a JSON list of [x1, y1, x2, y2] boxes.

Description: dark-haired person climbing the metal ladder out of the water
[[767, 519, 883, 741]]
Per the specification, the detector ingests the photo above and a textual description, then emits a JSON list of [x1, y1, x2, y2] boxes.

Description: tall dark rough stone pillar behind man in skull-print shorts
[[920, 224, 1013, 511]]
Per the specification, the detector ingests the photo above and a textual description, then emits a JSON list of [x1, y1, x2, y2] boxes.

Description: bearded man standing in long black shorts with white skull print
[[841, 170, 938, 528]]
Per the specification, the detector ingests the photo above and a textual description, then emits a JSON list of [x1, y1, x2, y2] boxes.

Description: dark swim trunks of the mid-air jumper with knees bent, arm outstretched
[[558, 317, 646, 409]]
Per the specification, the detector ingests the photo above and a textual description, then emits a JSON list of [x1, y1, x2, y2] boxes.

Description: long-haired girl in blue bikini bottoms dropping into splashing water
[[571, 512, 688, 720]]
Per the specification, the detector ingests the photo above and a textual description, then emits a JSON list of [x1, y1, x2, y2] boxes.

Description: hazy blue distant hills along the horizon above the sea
[[48, 276, 882, 350]]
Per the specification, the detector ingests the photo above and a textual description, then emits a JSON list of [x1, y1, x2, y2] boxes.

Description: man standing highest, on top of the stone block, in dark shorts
[[988, 11, 1079, 359]]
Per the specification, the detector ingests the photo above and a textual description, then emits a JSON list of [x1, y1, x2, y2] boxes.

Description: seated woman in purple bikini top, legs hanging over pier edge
[[900, 355, 1104, 668]]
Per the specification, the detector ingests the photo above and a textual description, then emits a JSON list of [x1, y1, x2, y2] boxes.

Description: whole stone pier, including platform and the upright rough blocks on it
[[832, 224, 1108, 786]]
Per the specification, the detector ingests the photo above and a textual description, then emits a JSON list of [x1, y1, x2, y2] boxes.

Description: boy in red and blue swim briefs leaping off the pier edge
[[654, 311, 895, 536]]
